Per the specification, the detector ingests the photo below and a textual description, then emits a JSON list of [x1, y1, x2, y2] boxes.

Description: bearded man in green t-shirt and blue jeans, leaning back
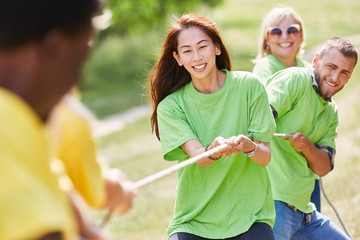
[[266, 37, 357, 240]]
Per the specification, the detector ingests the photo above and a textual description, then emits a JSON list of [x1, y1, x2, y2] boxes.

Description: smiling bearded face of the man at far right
[[313, 48, 355, 98]]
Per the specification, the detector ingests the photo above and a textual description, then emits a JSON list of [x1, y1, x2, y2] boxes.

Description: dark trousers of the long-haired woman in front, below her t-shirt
[[169, 222, 275, 240]]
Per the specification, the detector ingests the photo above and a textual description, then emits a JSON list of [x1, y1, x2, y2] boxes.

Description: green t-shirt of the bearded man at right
[[266, 67, 338, 213]]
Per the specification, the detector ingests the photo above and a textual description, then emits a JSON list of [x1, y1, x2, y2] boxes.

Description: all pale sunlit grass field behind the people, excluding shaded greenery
[[86, 0, 360, 240]]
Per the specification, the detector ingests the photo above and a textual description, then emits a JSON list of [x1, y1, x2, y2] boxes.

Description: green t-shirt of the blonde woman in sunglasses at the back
[[252, 54, 311, 84]]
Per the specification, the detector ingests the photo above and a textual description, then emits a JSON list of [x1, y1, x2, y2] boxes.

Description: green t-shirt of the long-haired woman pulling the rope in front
[[157, 71, 275, 238]]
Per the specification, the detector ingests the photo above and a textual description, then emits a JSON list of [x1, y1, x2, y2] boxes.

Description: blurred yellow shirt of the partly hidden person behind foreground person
[[49, 96, 106, 208]]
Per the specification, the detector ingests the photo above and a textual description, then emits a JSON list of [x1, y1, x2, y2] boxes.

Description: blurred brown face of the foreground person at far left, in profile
[[37, 26, 91, 119]]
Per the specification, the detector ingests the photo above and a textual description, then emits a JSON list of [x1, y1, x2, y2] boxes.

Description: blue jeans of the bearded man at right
[[273, 201, 350, 240]]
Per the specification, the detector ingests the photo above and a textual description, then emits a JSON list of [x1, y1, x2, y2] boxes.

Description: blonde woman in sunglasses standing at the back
[[253, 7, 311, 84]]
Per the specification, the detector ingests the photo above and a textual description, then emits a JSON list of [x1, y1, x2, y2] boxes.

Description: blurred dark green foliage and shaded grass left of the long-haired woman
[[80, 0, 222, 118]]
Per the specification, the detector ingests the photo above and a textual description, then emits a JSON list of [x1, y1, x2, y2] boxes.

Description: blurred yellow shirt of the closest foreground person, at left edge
[[0, 88, 76, 240]]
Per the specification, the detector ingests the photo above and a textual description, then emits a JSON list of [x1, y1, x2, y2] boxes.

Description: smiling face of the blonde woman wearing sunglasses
[[266, 17, 303, 65]]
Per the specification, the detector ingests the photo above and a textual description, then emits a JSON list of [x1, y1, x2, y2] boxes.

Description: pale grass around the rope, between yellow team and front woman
[[94, 118, 176, 240]]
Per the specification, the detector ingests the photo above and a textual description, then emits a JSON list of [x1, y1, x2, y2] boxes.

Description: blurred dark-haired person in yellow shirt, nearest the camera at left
[[0, 0, 100, 240]]
